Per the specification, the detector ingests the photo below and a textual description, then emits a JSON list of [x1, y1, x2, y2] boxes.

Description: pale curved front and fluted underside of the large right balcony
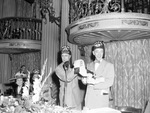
[[66, 13, 150, 46]]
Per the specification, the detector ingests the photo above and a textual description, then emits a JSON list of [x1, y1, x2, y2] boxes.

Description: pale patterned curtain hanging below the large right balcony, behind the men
[[85, 39, 150, 108]]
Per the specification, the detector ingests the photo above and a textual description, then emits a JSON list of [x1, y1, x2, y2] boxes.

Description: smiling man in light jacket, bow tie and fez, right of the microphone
[[82, 41, 115, 109]]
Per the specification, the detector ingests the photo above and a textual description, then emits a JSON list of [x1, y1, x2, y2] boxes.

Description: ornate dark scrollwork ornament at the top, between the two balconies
[[38, 0, 60, 27]]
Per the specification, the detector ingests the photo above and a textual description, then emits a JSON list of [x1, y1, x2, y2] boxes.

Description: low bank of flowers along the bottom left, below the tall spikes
[[0, 96, 81, 113]]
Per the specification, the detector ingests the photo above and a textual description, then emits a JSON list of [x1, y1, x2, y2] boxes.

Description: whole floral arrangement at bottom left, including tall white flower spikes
[[0, 59, 81, 113]]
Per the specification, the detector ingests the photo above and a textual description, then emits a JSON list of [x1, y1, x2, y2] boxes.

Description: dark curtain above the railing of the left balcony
[[0, 0, 41, 18]]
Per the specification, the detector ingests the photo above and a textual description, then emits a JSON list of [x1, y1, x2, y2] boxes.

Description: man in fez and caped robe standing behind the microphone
[[55, 46, 81, 109]]
